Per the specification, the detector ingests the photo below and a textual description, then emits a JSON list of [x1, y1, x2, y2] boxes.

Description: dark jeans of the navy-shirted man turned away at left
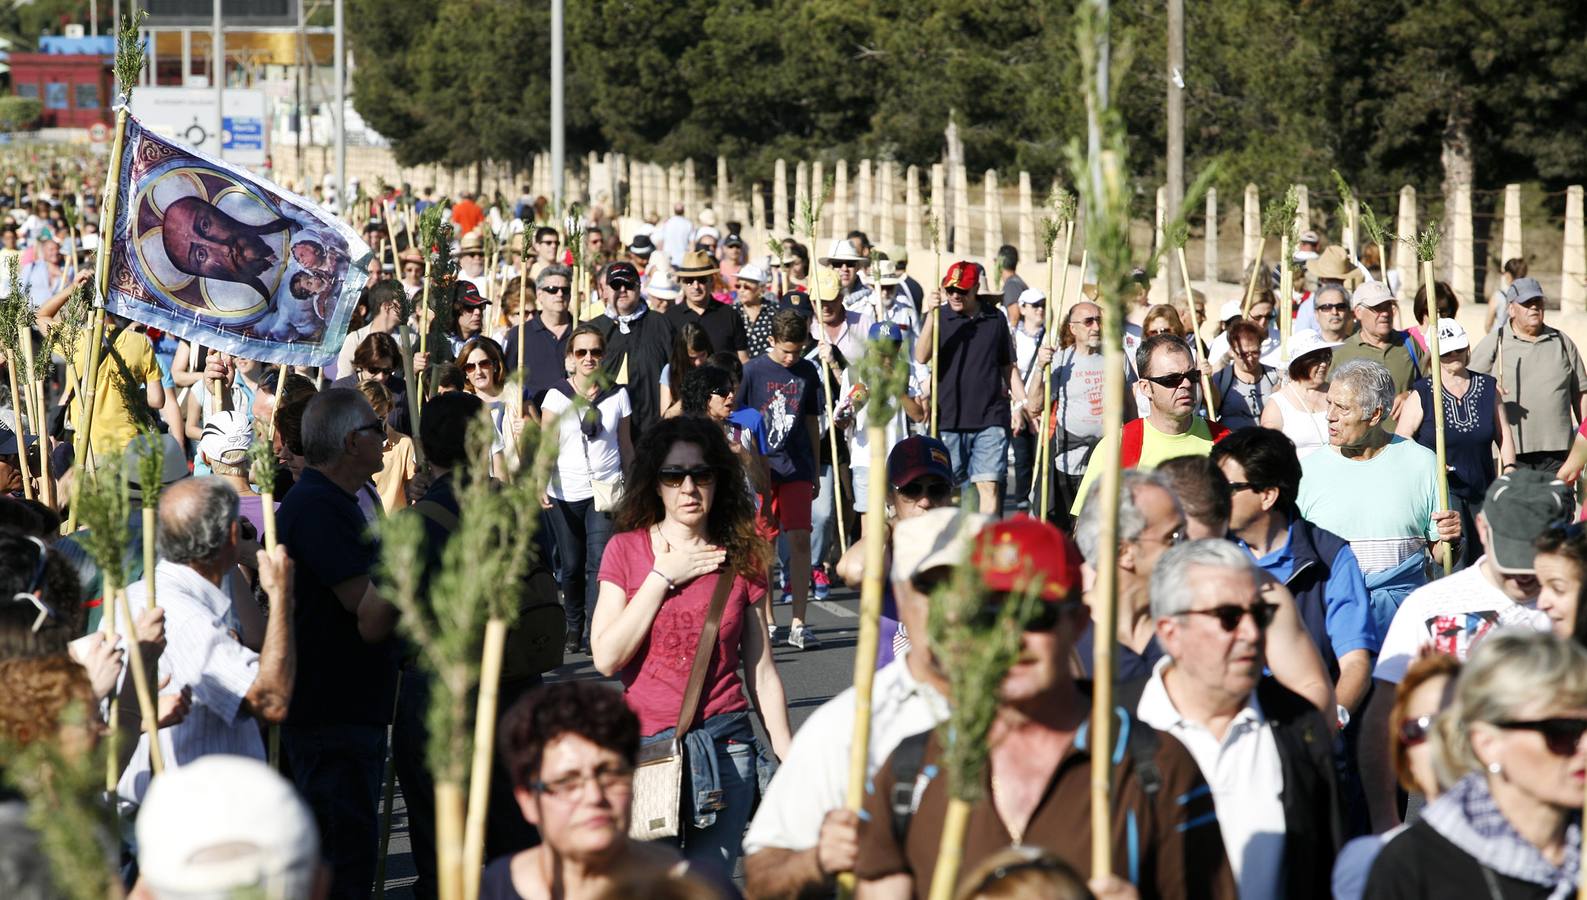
[[281, 725, 386, 900]]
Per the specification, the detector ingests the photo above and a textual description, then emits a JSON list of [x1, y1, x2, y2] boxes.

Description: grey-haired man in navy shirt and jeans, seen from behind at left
[[278, 387, 397, 900]]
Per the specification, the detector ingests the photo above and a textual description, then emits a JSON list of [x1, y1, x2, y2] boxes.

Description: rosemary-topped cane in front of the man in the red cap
[[926, 539, 1047, 900]]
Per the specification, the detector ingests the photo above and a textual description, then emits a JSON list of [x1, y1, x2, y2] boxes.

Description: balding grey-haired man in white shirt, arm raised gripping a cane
[[117, 476, 297, 805]]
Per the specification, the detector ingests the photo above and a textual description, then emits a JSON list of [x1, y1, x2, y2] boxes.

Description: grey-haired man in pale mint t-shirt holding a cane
[[1295, 359, 1460, 635]]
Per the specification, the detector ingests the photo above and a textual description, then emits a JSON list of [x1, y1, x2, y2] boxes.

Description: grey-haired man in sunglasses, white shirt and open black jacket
[[1130, 540, 1341, 897]]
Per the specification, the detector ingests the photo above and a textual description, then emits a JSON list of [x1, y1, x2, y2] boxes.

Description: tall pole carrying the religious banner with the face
[[65, 11, 148, 533]]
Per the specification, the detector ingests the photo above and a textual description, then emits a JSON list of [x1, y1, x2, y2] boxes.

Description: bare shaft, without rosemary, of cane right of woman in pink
[[838, 416, 888, 895]]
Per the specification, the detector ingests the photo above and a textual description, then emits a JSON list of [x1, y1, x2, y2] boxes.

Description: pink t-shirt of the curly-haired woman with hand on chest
[[600, 530, 767, 737]]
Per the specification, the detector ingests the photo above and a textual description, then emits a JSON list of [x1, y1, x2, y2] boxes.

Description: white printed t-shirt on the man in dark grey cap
[[1373, 557, 1549, 684]]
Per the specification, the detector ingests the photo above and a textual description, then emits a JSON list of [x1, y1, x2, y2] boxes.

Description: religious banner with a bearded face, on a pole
[[105, 116, 370, 365]]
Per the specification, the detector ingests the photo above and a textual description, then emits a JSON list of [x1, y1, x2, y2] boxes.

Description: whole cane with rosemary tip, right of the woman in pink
[[838, 341, 909, 895]]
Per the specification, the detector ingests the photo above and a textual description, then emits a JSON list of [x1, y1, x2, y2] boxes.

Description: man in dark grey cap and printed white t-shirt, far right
[[1360, 470, 1574, 832]]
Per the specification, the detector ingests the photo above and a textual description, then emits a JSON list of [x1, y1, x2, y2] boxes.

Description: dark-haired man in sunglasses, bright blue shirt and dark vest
[[1211, 429, 1382, 724]]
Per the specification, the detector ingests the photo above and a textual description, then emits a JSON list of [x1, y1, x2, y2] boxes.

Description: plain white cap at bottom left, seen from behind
[[138, 754, 321, 897]]
